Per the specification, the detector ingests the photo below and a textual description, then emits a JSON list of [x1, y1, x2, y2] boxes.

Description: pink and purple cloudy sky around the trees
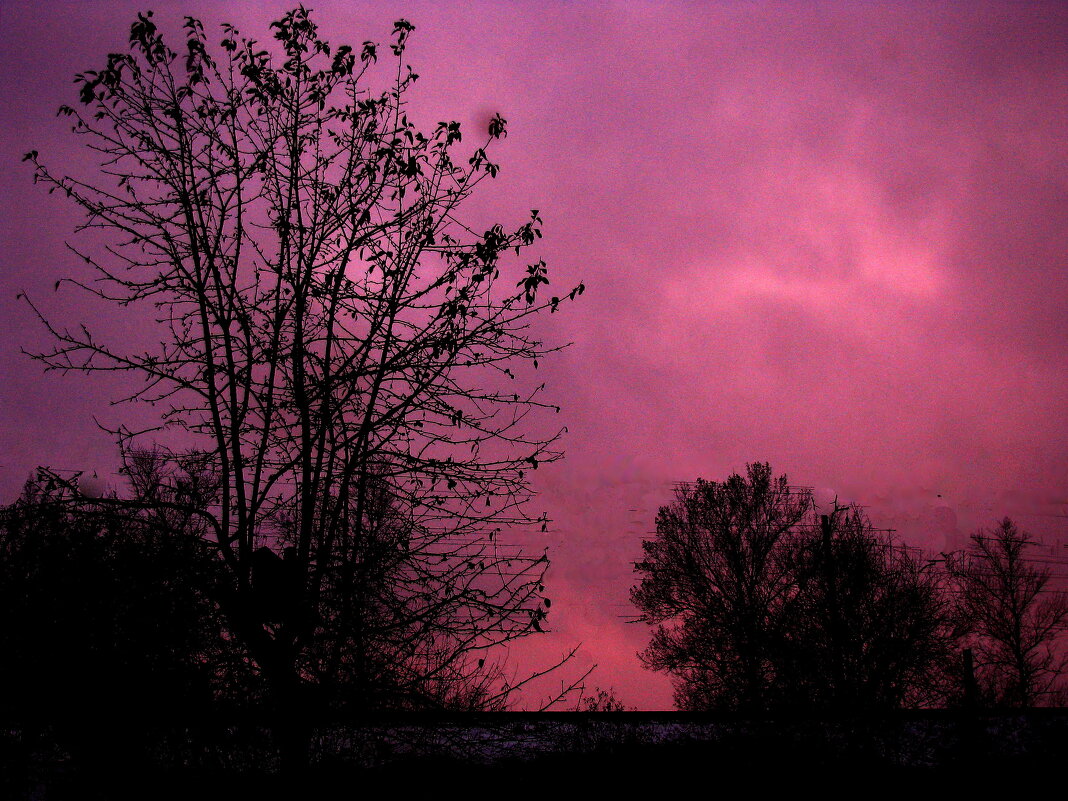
[[0, 0, 1068, 708]]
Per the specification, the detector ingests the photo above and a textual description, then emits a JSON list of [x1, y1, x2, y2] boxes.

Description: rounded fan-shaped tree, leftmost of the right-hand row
[[631, 464, 811, 709]]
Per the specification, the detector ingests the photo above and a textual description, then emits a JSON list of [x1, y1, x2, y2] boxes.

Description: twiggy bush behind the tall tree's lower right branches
[[292, 461, 530, 710]]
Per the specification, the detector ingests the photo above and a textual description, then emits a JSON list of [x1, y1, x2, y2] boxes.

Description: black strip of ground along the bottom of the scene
[[0, 709, 1068, 801]]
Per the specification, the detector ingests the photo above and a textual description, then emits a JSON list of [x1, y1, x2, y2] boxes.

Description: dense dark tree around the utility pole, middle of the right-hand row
[[781, 504, 956, 710]]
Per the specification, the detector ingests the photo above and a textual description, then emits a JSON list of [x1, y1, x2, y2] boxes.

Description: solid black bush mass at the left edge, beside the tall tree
[[0, 484, 254, 724]]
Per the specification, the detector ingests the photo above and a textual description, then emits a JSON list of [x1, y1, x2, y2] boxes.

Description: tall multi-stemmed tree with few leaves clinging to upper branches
[[18, 7, 583, 764]]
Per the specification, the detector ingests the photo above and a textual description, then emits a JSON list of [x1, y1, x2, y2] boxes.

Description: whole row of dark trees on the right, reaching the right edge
[[632, 464, 1068, 712]]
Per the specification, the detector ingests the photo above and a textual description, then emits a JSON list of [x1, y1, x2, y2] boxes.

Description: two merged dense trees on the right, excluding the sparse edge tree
[[632, 464, 953, 711]]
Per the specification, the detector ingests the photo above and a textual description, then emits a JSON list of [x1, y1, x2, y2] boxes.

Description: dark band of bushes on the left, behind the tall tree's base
[[0, 452, 545, 727]]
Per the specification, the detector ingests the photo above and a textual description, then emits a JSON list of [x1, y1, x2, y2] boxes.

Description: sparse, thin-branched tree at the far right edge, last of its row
[[951, 518, 1068, 707]]
